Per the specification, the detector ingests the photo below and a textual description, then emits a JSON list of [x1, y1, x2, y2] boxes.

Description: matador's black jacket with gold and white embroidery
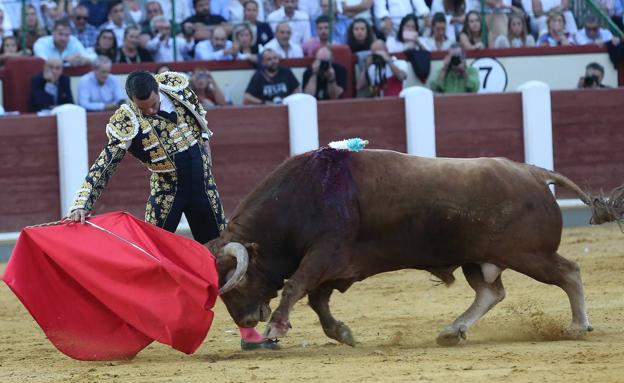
[[71, 72, 214, 214]]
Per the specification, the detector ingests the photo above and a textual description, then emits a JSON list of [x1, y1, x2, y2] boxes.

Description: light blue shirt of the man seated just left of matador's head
[[78, 72, 126, 112]]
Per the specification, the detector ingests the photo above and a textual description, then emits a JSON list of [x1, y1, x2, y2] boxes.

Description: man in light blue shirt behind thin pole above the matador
[[146, 15, 194, 62]]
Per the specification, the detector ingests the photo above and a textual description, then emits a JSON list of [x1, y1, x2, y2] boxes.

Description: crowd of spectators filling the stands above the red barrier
[[0, 0, 624, 110]]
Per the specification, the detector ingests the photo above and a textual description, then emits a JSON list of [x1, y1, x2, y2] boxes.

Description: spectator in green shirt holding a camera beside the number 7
[[430, 43, 479, 93]]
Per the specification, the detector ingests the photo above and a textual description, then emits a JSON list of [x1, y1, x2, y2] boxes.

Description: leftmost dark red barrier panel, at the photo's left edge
[[0, 115, 61, 232]]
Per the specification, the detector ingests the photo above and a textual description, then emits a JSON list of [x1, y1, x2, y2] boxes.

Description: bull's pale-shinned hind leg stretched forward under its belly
[[436, 263, 505, 346]]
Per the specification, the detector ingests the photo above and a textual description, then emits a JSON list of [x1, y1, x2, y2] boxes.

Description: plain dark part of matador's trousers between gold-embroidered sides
[[163, 144, 219, 243]]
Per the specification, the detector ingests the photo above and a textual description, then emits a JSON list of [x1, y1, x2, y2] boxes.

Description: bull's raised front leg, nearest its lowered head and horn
[[264, 253, 328, 338]]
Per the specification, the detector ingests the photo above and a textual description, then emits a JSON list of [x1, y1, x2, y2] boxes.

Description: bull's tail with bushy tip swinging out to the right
[[531, 166, 624, 225]]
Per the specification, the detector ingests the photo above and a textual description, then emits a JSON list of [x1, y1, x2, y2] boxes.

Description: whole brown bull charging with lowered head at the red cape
[[207, 148, 624, 345]]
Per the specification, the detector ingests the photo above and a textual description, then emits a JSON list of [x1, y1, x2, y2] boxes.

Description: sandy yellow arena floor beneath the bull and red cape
[[0, 225, 624, 383]]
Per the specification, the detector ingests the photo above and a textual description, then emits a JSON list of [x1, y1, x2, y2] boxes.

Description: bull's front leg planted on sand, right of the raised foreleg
[[308, 282, 355, 346]]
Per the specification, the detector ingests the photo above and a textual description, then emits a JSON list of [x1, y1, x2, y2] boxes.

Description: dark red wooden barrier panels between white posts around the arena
[[0, 89, 624, 232]]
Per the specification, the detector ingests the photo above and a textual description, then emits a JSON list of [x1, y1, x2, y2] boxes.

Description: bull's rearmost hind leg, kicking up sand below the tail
[[509, 253, 593, 335]]
